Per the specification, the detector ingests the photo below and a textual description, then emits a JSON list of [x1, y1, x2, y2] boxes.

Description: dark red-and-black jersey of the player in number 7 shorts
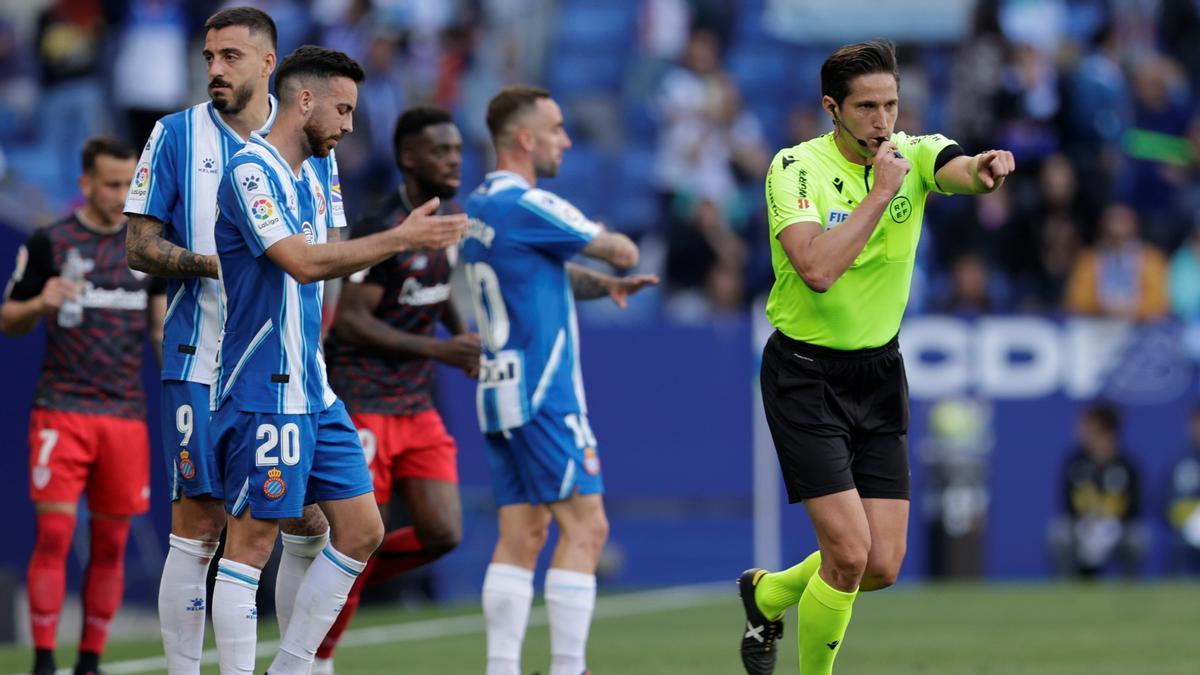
[[6, 215, 166, 419]]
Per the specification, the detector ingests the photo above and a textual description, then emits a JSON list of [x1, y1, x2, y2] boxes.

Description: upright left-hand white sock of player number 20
[[212, 558, 263, 675]]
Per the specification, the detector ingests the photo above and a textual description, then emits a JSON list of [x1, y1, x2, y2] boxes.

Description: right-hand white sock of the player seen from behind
[[546, 567, 596, 675]]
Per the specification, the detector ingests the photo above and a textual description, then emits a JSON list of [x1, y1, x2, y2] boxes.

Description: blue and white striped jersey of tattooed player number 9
[[125, 96, 346, 384]]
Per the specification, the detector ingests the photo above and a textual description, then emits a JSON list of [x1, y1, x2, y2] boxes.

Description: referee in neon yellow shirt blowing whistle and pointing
[[738, 41, 1015, 675]]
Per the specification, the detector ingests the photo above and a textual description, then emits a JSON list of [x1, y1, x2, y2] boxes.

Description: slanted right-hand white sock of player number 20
[[268, 544, 367, 675]]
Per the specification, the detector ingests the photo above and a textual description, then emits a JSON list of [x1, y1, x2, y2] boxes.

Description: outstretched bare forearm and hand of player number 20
[[266, 198, 467, 283]]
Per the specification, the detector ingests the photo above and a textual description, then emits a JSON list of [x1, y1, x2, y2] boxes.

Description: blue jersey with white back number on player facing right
[[462, 171, 600, 434]]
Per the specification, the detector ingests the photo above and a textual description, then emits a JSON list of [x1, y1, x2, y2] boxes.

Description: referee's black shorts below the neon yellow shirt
[[760, 330, 910, 503]]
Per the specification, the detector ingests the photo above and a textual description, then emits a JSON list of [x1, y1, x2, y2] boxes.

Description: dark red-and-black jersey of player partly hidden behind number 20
[[325, 187, 462, 416]]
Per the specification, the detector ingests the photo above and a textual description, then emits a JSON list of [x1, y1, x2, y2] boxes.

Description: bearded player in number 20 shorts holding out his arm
[[204, 47, 467, 675]]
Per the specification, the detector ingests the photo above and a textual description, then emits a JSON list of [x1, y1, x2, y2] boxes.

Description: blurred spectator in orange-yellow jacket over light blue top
[[1067, 204, 1169, 321]]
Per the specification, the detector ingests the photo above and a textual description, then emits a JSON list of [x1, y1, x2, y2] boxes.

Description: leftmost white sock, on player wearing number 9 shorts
[[158, 534, 217, 675]]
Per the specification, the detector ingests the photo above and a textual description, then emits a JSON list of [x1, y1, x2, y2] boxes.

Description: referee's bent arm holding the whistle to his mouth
[[767, 141, 911, 293]]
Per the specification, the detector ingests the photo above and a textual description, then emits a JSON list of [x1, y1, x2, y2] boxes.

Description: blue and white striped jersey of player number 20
[[211, 133, 337, 414]]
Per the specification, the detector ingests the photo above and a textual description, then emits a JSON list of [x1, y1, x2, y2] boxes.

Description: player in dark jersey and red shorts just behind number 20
[[313, 106, 479, 675]]
